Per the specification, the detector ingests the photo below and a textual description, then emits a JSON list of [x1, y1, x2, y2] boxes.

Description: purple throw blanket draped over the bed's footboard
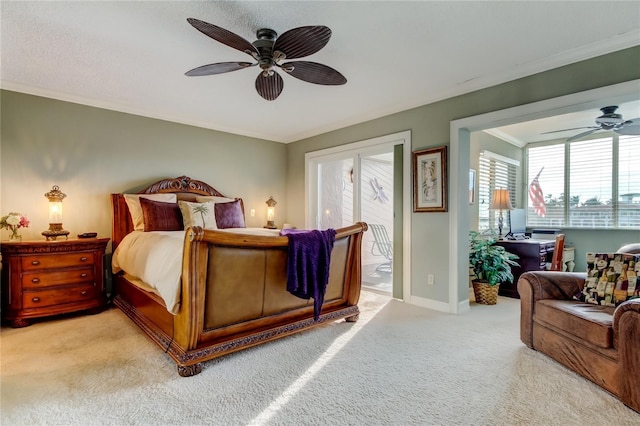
[[280, 229, 336, 321]]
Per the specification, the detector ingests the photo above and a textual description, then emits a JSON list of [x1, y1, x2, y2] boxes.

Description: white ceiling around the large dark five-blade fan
[[0, 1, 640, 143]]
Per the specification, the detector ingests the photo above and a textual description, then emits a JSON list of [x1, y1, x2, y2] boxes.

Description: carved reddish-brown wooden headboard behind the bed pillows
[[111, 176, 225, 250]]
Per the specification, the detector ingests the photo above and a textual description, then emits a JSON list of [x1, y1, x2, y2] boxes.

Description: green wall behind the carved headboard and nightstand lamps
[[0, 90, 286, 248]]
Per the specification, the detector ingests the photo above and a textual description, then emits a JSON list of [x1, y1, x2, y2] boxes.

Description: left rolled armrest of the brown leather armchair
[[518, 271, 587, 348]]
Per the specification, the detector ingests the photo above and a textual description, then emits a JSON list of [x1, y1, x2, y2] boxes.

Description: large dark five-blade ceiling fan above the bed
[[185, 18, 347, 101]]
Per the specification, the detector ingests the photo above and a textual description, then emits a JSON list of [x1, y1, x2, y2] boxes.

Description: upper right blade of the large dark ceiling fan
[[273, 25, 331, 59]]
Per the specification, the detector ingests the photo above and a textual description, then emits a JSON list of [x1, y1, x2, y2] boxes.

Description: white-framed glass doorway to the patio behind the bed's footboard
[[306, 132, 410, 299]]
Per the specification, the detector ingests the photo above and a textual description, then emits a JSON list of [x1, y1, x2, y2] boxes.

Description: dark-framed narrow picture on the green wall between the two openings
[[412, 146, 447, 212]]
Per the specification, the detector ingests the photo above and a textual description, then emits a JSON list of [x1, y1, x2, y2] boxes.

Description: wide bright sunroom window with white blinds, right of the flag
[[527, 135, 640, 228]]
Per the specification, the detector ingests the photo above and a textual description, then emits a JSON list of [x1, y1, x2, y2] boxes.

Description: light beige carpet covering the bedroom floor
[[0, 292, 640, 426]]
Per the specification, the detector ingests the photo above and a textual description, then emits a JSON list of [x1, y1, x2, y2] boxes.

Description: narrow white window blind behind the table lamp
[[478, 151, 519, 231]]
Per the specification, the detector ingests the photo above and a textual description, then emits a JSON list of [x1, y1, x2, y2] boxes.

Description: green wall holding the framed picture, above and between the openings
[[287, 47, 640, 303]]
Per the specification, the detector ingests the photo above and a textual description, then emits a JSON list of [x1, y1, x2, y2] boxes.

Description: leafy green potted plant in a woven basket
[[469, 231, 518, 305]]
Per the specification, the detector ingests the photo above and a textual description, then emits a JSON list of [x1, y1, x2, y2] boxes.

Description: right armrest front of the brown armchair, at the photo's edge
[[613, 299, 640, 412]]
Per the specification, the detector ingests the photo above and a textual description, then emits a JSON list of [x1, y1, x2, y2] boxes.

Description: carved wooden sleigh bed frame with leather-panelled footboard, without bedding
[[111, 176, 367, 377]]
